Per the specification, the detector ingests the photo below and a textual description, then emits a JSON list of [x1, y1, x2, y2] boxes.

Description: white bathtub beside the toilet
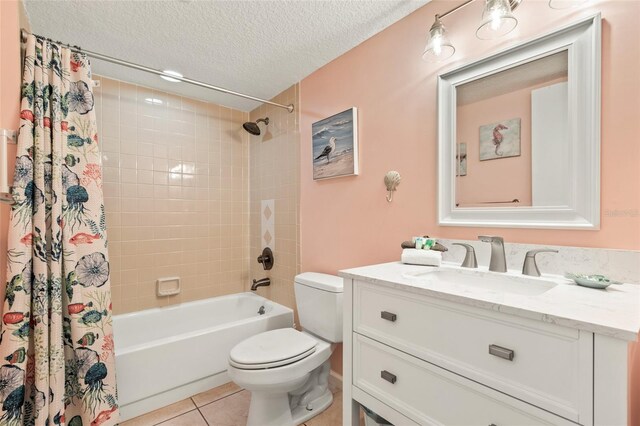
[[113, 293, 293, 420]]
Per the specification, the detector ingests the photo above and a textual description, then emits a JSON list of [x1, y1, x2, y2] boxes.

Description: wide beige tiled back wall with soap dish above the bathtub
[[95, 77, 250, 313]]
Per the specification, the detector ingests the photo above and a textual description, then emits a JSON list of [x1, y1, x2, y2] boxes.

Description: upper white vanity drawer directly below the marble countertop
[[353, 281, 593, 424]]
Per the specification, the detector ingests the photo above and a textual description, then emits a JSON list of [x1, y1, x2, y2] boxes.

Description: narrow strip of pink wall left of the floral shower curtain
[[0, 0, 22, 306]]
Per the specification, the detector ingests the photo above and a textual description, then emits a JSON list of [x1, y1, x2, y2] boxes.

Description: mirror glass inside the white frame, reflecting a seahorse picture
[[455, 50, 571, 208]]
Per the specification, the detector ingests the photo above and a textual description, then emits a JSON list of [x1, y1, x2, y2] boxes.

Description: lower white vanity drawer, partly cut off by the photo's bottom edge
[[353, 333, 575, 426]]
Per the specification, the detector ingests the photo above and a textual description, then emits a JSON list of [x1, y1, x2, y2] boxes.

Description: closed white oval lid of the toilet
[[229, 328, 318, 369]]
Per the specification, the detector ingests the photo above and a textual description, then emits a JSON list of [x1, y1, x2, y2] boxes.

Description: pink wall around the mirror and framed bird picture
[[300, 1, 640, 412]]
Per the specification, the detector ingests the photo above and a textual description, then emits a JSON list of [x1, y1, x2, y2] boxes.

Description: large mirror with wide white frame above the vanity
[[438, 14, 601, 230]]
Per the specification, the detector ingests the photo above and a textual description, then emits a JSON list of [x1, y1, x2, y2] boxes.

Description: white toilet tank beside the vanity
[[294, 272, 343, 343]]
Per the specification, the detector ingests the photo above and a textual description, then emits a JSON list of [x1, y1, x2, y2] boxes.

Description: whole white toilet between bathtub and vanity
[[228, 272, 342, 426]]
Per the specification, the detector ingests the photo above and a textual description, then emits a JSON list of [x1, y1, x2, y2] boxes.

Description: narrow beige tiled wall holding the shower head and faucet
[[249, 84, 300, 309]]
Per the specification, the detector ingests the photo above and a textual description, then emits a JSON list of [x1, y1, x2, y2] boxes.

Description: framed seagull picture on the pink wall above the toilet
[[311, 107, 358, 180]]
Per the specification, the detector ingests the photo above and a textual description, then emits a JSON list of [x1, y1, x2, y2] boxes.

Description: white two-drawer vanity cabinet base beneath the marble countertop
[[342, 264, 638, 426]]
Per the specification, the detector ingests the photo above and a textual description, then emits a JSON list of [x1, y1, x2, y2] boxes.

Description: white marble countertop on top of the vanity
[[339, 262, 640, 341]]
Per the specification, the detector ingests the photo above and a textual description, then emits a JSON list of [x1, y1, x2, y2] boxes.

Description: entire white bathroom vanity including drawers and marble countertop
[[340, 263, 640, 426]]
